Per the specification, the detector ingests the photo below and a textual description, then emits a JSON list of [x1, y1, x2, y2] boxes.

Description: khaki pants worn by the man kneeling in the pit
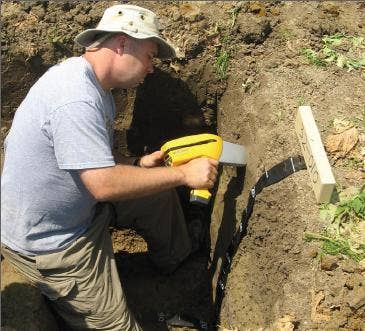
[[2, 191, 191, 330]]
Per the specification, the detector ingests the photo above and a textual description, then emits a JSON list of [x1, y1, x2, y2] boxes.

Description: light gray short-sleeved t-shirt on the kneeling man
[[1, 57, 115, 255]]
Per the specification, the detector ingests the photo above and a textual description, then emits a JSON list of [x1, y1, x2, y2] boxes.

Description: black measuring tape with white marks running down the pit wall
[[144, 155, 307, 330]]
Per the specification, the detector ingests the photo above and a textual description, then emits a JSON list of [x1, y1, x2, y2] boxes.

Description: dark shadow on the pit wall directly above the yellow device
[[127, 68, 216, 155]]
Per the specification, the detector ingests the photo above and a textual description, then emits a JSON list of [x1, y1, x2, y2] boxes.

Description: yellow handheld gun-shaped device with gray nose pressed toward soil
[[161, 133, 246, 204]]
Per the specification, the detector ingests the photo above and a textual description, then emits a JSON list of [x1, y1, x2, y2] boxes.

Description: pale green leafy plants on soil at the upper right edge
[[302, 33, 365, 71]]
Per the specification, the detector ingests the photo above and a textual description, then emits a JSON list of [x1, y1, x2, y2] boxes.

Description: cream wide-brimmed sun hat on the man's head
[[75, 5, 176, 59]]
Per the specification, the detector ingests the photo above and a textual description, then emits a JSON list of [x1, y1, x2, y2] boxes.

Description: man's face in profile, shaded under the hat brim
[[115, 38, 158, 88]]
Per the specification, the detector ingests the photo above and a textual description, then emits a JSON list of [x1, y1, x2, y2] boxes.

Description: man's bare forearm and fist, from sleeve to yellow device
[[79, 158, 218, 201]]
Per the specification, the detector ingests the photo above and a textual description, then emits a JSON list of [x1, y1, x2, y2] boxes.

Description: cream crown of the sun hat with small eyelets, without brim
[[97, 5, 159, 35]]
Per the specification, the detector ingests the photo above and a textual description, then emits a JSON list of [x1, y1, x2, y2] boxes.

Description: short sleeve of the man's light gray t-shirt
[[49, 102, 115, 170]]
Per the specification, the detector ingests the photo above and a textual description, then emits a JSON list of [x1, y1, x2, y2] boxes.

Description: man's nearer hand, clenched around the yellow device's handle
[[176, 157, 218, 189]]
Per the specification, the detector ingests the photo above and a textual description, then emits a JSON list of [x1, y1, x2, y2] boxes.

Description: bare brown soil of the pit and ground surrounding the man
[[1, 1, 365, 330]]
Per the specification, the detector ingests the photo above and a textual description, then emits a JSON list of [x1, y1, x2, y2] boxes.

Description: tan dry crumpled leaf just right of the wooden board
[[325, 127, 359, 157]]
